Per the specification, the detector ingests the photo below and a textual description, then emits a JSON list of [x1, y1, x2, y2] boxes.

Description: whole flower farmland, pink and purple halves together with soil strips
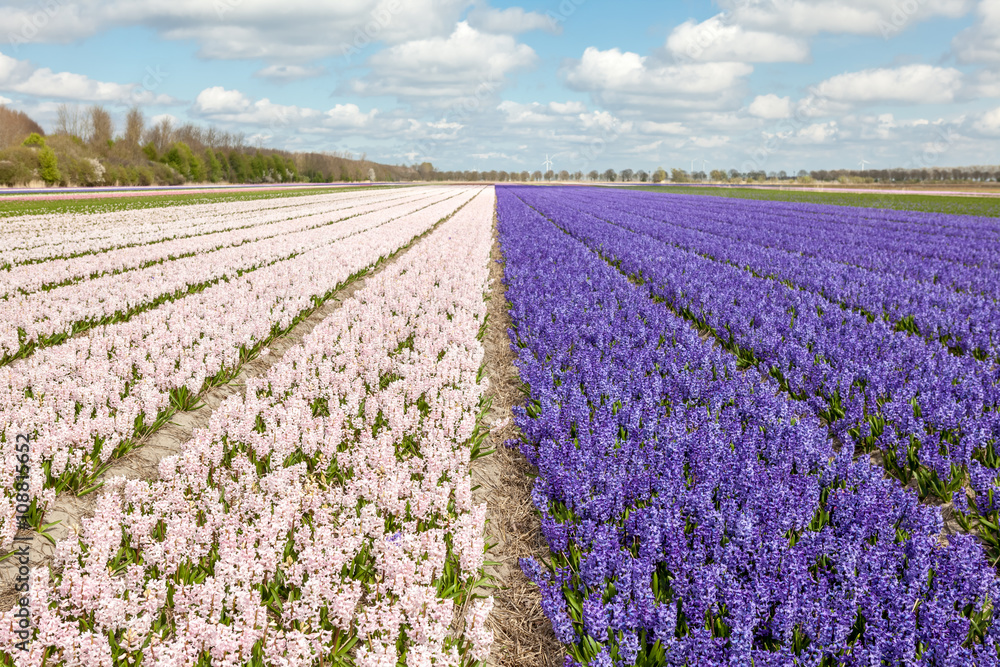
[[0, 185, 1000, 667]]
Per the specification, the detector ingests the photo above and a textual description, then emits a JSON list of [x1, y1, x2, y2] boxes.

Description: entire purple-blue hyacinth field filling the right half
[[498, 188, 1000, 666]]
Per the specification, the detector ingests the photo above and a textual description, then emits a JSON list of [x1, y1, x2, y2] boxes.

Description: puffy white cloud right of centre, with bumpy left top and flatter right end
[[566, 47, 753, 106]]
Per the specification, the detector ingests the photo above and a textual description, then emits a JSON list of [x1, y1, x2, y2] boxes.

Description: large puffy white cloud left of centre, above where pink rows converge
[[354, 21, 537, 100]]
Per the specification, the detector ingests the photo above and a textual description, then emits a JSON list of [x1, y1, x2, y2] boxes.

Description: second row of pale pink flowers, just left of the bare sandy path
[[0, 189, 475, 547]]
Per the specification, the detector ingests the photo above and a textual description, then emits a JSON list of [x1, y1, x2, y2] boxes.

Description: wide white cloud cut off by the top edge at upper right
[[719, 0, 973, 38]]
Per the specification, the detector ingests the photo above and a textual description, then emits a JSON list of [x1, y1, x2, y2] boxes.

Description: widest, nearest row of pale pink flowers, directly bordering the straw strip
[[0, 188, 494, 667]]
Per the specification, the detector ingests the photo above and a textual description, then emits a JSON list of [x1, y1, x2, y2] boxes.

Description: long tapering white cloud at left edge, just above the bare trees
[[0, 53, 176, 104]]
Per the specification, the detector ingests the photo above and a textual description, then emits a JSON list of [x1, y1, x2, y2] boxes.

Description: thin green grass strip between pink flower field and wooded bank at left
[[0, 186, 406, 219]]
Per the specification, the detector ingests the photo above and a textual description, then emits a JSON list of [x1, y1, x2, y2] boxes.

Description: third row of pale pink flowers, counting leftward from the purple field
[[0, 190, 453, 356]]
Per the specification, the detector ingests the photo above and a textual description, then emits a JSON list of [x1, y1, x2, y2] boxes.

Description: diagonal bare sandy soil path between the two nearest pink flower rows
[[0, 216, 450, 610]]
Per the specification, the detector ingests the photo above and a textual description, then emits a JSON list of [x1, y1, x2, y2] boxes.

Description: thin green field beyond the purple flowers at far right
[[634, 185, 1000, 218]]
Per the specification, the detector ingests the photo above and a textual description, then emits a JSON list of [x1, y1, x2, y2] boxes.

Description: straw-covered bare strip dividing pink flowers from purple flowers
[[472, 224, 563, 667]]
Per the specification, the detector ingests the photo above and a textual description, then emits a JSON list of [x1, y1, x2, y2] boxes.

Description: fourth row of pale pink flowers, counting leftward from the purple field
[[0, 190, 426, 297]]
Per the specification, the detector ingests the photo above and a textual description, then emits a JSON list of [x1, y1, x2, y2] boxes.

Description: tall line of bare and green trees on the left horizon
[[0, 105, 416, 186]]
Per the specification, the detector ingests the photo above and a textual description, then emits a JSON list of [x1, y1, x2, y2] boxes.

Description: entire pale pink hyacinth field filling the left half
[[0, 188, 495, 666]]
